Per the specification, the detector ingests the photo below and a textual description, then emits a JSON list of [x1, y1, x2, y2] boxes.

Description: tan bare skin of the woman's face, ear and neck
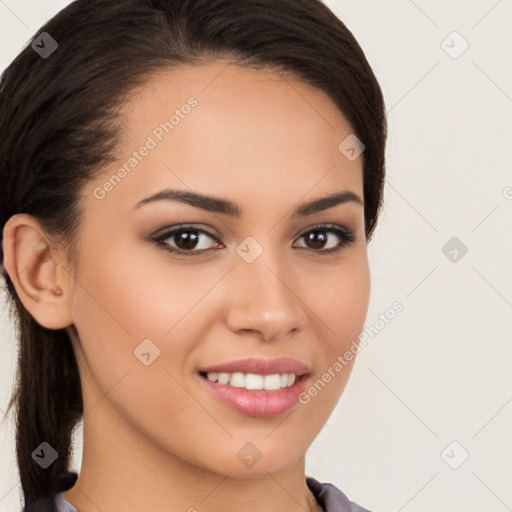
[[4, 61, 370, 512]]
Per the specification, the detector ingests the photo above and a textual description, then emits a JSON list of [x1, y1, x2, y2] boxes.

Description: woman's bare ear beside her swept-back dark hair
[[3, 213, 73, 329]]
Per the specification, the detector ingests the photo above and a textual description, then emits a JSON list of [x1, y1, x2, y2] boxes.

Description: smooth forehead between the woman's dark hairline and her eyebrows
[[85, 61, 362, 216]]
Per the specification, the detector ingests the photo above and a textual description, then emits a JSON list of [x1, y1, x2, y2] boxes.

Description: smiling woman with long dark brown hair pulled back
[[0, 0, 386, 512]]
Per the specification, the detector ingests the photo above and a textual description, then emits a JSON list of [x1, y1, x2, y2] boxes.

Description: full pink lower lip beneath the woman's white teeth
[[199, 375, 308, 418]]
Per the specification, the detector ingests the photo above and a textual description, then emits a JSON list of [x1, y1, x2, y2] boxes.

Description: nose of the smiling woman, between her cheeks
[[226, 251, 308, 341]]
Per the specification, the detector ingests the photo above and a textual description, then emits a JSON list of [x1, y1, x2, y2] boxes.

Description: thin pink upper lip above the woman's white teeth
[[199, 357, 309, 375]]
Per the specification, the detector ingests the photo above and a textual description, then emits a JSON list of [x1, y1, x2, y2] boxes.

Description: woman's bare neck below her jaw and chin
[[61, 401, 322, 512]]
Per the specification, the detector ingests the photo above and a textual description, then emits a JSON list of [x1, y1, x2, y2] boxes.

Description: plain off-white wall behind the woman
[[0, 0, 512, 512]]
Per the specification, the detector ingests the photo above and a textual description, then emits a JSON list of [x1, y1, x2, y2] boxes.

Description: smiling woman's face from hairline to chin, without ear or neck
[[64, 61, 370, 478]]
